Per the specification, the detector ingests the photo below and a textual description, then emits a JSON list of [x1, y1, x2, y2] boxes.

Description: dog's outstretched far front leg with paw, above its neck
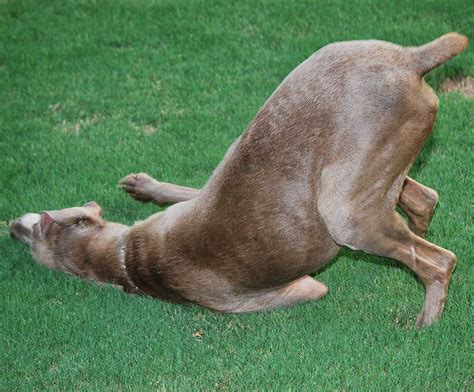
[[119, 173, 199, 204]]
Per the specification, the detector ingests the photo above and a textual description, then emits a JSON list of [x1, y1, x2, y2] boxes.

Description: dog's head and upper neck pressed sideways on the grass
[[10, 201, 129, 284]]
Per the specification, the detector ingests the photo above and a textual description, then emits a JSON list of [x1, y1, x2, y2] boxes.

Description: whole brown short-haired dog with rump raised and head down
[[11, 33, 467, 327]]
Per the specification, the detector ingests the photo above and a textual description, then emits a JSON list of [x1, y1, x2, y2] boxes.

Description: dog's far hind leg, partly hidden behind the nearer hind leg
[[398, 177, 439, 237]]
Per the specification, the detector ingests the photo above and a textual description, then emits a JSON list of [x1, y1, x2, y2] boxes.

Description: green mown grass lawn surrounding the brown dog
[[0, 0, 474, 391]]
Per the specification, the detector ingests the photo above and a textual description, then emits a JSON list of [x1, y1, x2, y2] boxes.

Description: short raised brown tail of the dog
[[410, 33, 468, 76]]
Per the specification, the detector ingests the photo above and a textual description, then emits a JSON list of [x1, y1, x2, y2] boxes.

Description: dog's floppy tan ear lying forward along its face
[[40, 201, 103, 239]]
